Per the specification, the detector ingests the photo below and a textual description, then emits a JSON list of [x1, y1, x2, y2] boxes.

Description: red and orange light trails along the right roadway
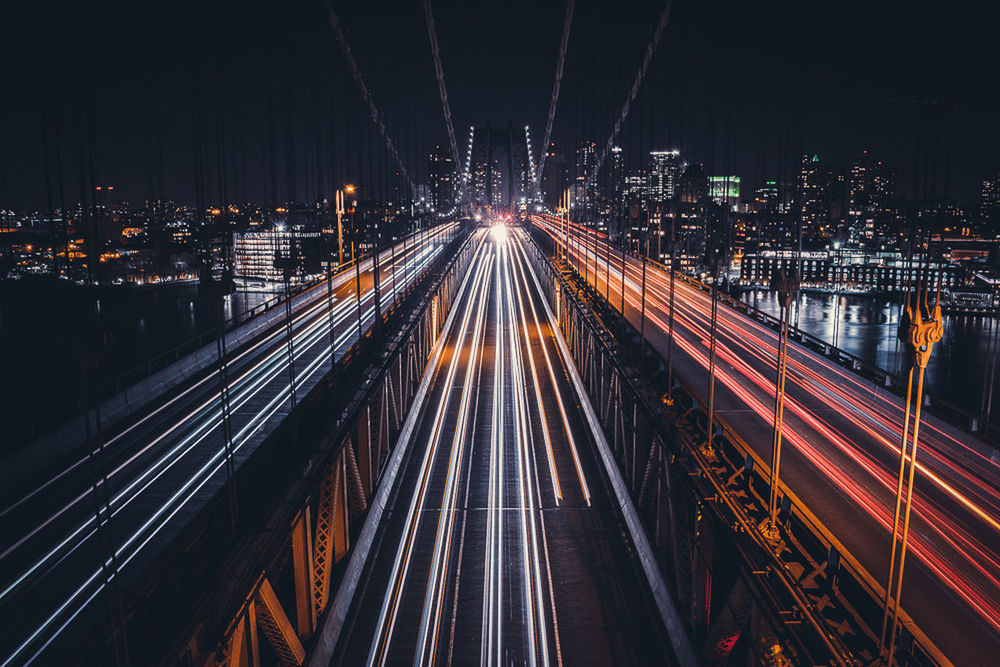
[[533, 216, 1000, 652]]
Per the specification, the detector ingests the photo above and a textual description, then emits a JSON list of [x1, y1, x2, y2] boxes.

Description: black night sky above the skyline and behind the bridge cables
[[0, 0, 1000, 209]]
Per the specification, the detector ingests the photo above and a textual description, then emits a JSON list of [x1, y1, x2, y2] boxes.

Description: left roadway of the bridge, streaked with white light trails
[[0, 225, 452, 665]]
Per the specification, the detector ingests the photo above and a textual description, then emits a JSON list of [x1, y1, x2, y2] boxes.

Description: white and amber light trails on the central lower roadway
[[359, 227, 591, 665]]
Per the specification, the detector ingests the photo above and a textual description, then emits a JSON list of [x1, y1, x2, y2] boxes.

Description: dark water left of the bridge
[[0, 282, 274, 451]]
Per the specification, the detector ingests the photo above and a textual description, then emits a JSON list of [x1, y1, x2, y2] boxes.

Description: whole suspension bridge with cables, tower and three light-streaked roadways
[[0, 0, 1000, 666]]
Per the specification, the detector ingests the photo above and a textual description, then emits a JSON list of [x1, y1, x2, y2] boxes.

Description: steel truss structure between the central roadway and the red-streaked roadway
[[529, 227, 947, 665]]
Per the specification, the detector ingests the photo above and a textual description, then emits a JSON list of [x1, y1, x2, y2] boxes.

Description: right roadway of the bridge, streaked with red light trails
[[533, 216, 1000, 665]]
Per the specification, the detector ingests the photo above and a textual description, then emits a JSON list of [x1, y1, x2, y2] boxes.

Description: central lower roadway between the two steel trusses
[[332, 232, 674, 665]]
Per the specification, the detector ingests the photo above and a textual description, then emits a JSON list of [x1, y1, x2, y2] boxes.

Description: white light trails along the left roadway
[[0, 226, 450, 665]]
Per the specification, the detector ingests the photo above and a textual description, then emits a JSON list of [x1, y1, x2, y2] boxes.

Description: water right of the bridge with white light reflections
[[742, 291, 998, 415]]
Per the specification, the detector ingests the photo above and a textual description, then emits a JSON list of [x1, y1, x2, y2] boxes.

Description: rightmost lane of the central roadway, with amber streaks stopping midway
[[521, 235, 673, 665]]
